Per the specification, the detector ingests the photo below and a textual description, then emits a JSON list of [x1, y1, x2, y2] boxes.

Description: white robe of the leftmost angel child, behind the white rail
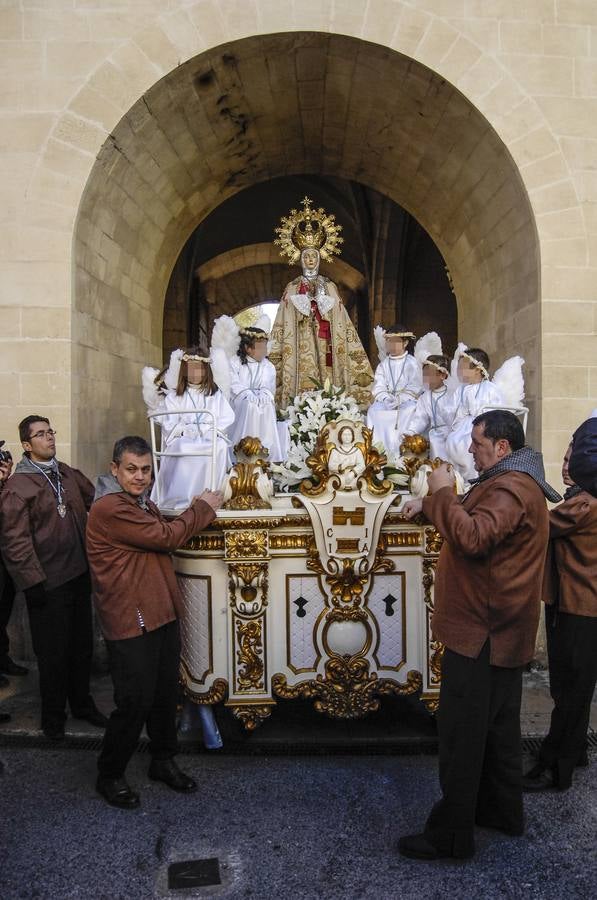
[[151, 386, 234, 509]]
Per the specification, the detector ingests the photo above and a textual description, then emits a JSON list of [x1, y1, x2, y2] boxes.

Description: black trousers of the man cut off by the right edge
[[539, 606, 597, 789]]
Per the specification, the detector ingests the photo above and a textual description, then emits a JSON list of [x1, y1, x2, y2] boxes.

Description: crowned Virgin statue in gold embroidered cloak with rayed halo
[[269, 197, 373, 409]]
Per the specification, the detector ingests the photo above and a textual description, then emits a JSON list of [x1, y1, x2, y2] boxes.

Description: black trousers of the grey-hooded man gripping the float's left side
[[98, 622, 180, 778]]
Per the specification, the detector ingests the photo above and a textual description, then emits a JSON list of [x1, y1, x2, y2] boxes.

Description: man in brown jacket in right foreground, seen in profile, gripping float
[[398, 410, 559, 859]]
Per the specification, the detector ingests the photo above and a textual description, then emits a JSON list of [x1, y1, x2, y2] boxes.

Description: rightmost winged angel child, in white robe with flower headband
[[446, 344, 524, 481]]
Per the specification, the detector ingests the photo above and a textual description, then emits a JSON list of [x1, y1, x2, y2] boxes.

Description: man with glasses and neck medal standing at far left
[[0, 415, 107, 740]]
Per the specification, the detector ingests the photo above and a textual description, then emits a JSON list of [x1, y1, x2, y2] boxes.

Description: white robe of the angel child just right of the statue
[[367, 353, 423, 453]]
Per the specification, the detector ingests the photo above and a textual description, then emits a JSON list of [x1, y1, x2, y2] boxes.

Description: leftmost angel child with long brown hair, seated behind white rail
[[143, 347, 234, 509]]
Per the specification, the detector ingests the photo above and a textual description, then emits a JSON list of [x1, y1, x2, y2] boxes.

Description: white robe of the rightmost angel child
[[446, 380, 505, 481]]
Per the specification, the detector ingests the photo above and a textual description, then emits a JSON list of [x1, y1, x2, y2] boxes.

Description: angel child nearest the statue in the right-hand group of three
[[367, 324, 423, 453]]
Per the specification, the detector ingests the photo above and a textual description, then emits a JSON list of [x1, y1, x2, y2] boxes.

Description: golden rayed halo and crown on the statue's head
[[274, 197, 344, 265]]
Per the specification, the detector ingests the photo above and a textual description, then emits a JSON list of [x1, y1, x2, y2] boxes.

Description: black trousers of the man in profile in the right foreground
[[425, 641, 524, 853]]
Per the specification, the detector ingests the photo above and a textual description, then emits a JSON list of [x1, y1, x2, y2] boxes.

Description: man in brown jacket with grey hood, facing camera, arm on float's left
[[87, 436, 223, 809]]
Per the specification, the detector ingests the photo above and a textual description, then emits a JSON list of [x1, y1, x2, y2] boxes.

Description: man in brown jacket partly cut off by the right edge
[[523, 418, 597, 791]]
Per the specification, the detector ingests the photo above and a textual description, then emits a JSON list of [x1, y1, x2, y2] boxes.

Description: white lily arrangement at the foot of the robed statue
[[270, 378, 363, 491]]
